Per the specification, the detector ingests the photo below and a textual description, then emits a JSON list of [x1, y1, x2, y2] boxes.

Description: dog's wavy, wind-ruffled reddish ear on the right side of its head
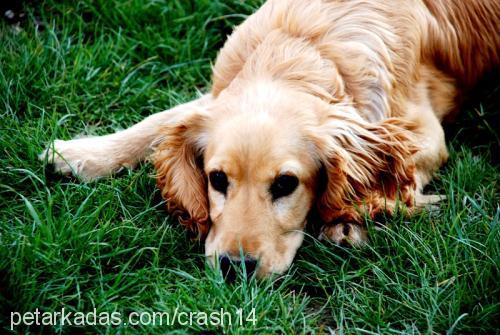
[[313, 111, 417, 223]]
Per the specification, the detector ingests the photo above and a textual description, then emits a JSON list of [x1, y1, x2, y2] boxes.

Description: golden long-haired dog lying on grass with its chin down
[[41, 0, 500, 277]]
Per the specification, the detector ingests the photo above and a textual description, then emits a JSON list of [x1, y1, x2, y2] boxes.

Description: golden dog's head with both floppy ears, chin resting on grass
[[154, 82, 412, 276]]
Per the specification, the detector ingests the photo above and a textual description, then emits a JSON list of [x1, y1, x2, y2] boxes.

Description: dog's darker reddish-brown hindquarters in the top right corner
[[424, 0, 500, 88]]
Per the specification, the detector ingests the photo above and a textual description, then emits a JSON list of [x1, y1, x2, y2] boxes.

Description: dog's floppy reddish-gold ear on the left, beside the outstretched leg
[[153, 113, 210, 238]]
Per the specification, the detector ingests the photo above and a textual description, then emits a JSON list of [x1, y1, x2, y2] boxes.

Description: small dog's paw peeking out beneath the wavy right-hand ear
[[319, 223, 367, 246]]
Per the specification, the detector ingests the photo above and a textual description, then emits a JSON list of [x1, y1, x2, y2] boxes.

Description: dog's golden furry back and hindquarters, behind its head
[[212, 0, 500, 120]]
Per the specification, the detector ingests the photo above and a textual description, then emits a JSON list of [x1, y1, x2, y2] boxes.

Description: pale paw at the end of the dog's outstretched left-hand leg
[[38, 137, 120, 181]]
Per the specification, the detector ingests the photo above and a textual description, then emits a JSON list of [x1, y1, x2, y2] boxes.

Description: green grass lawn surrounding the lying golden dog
[[0, 0, 500, 334]]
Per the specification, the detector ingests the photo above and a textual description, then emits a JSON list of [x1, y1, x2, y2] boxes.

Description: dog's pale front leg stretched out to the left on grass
[[39, 95, 212, 181]]
